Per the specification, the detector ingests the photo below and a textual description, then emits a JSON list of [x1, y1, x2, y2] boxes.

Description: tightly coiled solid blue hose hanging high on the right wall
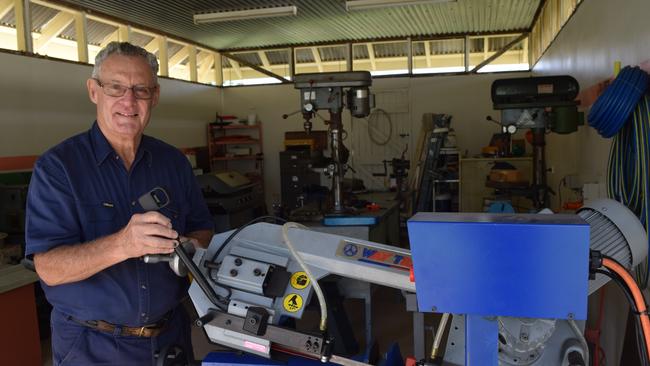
[[587, 66, 648, 138]]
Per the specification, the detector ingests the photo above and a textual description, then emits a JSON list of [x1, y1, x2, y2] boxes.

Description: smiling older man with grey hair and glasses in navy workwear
[[26, 42, 213, 365]]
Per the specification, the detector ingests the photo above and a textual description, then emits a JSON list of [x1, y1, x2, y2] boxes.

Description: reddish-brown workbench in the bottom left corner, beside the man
[[0, 264, 42, 366]]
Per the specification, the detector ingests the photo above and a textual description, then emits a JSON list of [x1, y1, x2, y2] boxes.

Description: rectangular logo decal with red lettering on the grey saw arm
[[336, 240, 413, 271]]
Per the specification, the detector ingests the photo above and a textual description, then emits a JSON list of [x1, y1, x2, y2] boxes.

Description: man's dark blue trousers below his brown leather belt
[[51, 305, 192, 366]]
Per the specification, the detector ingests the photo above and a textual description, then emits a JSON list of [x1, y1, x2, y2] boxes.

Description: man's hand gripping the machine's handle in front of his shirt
[[115, 211, 179, 258]]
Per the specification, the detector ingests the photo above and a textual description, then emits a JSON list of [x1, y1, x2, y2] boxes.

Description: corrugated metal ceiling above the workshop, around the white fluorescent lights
[[53, 0, 541, 50]]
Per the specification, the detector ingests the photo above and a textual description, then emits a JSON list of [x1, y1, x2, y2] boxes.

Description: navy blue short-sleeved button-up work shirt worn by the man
[[25, 122, 214, 326]]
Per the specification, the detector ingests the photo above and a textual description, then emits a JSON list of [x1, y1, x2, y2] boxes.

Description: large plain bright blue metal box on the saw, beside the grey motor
[[408, 213, 589, 319]]
